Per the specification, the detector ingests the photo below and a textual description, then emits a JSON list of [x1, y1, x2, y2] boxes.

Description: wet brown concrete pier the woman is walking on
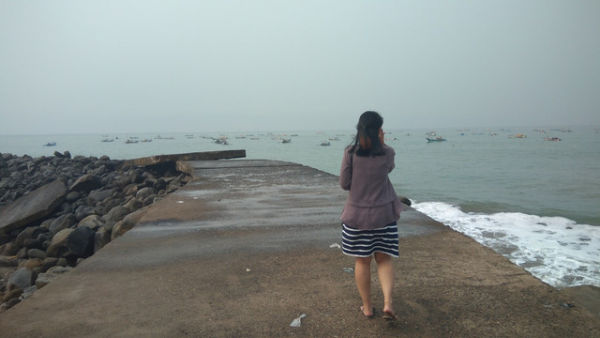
[[0, 160, 600, 337]]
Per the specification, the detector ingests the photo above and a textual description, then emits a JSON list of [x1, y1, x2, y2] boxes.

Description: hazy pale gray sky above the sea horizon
[[0, 0, 600, 134]]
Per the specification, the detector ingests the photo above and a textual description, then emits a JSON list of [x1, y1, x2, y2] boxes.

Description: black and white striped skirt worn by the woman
[[342, 222, 398, 257]]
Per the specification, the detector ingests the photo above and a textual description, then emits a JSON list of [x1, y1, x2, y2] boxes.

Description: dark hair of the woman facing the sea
[[352, 111, 385, 156]]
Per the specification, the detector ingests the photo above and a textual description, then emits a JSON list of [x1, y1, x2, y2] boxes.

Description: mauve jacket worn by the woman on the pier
[[340, 145, 402, 229]]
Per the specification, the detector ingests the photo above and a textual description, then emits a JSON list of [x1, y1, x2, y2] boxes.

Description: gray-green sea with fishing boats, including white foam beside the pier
[[0, 128, 600, 287]]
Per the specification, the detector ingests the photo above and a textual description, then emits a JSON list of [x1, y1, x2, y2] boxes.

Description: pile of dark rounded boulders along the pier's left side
[[0, 151, 191, 312]]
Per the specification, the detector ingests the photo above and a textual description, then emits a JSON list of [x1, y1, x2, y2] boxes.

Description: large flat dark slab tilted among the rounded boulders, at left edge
[[0, 180, 67, 238]]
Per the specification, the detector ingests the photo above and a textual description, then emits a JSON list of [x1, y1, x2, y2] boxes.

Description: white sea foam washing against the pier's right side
[[413, 202, 600, 288]]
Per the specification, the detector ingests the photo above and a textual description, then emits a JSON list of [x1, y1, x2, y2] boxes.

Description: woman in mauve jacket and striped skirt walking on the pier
[[340, 111, 401, 320]]
